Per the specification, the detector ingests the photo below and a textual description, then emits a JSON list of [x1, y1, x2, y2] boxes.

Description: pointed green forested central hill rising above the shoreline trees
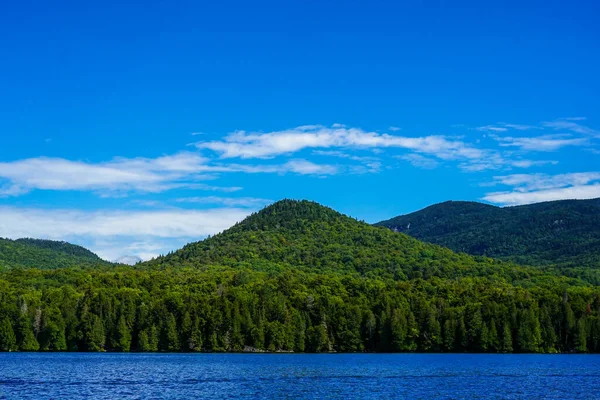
[[146, 200, 548, 279]]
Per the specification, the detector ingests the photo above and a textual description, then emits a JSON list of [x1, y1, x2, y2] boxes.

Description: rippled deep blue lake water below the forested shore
[[0, 353, 600, 399]]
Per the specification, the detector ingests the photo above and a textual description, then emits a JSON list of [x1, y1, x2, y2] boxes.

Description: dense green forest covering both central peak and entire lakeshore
[[0, 200, 600, 353]]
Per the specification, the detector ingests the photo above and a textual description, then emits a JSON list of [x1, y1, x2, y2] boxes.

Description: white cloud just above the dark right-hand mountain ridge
[[483, 172, 600, 205]]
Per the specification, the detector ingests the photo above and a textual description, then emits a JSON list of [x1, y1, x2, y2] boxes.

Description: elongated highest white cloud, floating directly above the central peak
[[196, 125, 484, 160]]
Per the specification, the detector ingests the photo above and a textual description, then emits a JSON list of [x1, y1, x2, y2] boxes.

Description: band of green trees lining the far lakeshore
[[0, 267, 600, 353]]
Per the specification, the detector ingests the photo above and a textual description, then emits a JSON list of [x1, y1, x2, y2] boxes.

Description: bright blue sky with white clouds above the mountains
[[0, 1, 600, 259]]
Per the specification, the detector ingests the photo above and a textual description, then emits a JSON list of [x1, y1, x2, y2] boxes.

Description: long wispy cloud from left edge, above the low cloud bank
[[0, 152, 338, 197]]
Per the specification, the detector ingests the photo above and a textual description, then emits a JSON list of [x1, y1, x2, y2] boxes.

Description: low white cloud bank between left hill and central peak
[[0, 207, 253, 260]]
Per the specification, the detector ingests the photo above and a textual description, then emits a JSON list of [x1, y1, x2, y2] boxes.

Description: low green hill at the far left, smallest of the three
[[0, 238, 111, 269]]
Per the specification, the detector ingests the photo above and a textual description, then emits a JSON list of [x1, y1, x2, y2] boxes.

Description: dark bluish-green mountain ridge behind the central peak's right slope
[[375, 199, 600, 267]]
